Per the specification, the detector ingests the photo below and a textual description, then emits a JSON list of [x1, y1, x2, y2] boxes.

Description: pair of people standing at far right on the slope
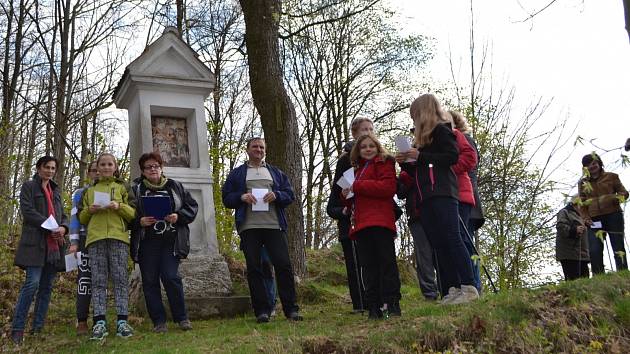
[[556, 153, 628, 280]]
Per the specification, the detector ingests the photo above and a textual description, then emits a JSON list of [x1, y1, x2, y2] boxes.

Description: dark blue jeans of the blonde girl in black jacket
[[420, 197, 475, 296]]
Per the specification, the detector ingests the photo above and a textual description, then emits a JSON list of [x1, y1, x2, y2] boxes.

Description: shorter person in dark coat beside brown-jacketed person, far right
[[556, 198, 589, 280]]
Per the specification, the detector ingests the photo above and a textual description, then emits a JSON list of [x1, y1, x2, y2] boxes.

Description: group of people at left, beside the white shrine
[[11, 152, 198, 344]]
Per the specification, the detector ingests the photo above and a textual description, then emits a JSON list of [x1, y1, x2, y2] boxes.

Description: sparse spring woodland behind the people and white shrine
[[0, 0, 627, 289]]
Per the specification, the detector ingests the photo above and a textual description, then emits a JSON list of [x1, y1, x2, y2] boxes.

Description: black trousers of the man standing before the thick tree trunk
[[241, 229, 299, 316]]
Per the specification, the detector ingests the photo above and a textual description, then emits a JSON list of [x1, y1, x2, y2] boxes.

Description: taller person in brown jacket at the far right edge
[[578, 152, 628, 274]]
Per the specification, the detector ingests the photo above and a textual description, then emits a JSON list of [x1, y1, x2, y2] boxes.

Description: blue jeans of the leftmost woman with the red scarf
[[11, 263, 57, 331]]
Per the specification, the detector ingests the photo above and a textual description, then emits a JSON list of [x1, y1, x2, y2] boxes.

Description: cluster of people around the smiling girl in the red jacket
[[327, 94, 483, 319]]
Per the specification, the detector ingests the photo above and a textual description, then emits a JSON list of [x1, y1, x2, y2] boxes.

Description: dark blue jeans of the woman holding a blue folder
[[138, 237, 188, 325]]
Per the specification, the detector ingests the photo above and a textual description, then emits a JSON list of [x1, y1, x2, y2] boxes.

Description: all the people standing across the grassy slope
[[11, 94, 628, 344]]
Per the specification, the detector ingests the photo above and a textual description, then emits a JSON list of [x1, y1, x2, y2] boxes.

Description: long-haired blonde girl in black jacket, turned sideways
[[403, 94, 479, 304]]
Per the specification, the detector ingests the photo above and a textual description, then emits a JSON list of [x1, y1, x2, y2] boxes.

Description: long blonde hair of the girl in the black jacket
[[409, 93, 449, 148]]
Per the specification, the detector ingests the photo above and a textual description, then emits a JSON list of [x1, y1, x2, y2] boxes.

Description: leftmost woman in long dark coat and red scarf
[[11, 156, 68, 344]]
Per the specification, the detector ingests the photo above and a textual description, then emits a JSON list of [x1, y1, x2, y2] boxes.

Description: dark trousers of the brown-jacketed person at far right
[[588, 211, 628, 274]]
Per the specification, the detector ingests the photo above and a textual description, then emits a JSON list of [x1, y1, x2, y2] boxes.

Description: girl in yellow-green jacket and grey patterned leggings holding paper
[[79, 153, 136, 340]]
